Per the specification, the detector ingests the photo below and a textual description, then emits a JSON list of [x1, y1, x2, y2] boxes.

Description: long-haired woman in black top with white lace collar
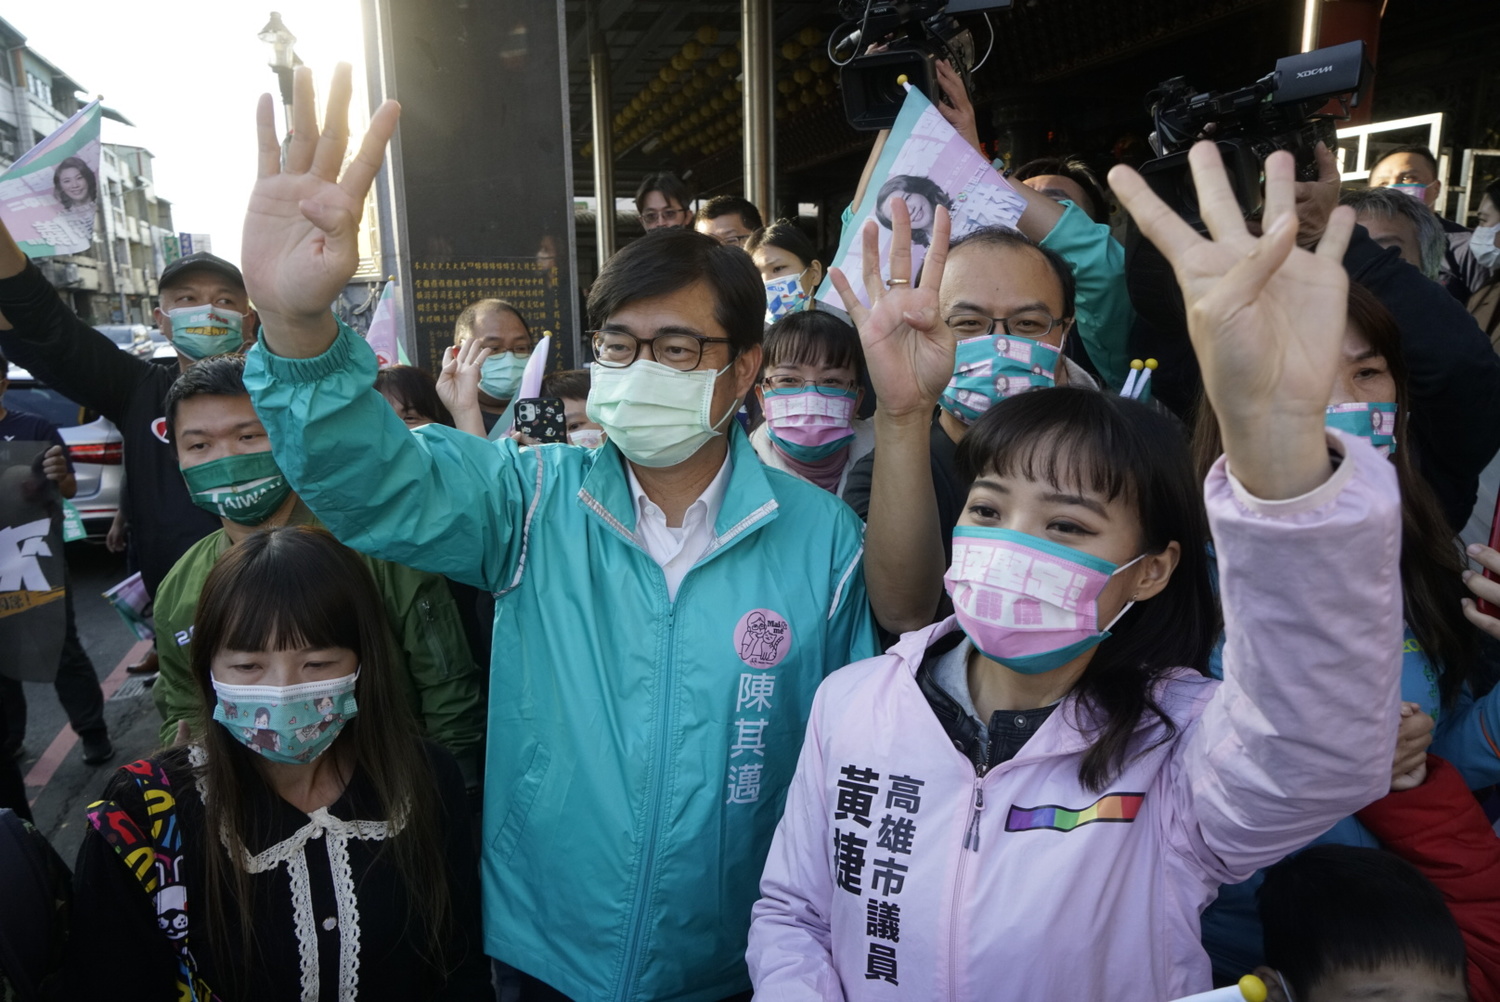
[[63, 528, 494, 1002]]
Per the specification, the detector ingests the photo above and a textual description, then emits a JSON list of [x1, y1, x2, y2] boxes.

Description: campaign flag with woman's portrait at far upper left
[[0, 101, 102, 258]]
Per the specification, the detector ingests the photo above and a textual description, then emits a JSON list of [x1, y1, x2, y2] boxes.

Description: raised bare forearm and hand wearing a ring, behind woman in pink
[[830, 198, 956, 633]]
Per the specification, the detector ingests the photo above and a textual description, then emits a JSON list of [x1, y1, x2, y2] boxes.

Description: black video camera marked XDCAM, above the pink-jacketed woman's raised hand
[[1140, 42, 1365, 231]]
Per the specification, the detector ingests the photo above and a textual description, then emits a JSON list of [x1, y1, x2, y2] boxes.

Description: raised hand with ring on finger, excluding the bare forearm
[[828, 197, 956, 423]]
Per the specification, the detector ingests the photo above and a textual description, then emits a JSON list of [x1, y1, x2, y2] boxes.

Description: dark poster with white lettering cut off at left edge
[[0, 441, 66, 683]]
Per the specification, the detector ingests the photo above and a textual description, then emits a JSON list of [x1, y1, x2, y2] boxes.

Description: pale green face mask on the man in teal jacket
[[588, 359, 740, 468]]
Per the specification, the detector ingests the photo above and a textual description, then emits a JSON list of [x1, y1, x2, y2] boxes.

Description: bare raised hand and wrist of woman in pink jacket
[[1110, 143, 1355, 501]]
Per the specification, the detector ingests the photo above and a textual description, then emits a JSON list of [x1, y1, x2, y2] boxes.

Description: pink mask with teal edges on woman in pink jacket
[[944, 525, 1145, 675]]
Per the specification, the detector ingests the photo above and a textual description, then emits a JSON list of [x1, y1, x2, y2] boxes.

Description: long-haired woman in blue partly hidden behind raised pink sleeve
[[1194, 285, 1500, 977]]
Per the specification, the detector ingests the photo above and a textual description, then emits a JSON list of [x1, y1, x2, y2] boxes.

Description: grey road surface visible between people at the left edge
[[21, 543, 159, 863]]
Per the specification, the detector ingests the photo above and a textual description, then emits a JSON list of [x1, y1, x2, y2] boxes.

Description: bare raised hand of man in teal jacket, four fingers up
[[240, 63, 401, 359]]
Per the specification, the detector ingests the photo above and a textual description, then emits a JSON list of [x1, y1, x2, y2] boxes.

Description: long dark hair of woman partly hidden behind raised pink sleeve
[[1193, 282, 1488, 708]]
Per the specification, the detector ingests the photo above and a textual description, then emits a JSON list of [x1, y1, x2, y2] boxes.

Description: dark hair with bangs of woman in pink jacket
[[957, 387, 1220, 792]]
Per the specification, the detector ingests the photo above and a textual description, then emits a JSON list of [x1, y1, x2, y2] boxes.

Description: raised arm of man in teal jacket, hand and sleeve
[[242, 65, 531, 590]]
